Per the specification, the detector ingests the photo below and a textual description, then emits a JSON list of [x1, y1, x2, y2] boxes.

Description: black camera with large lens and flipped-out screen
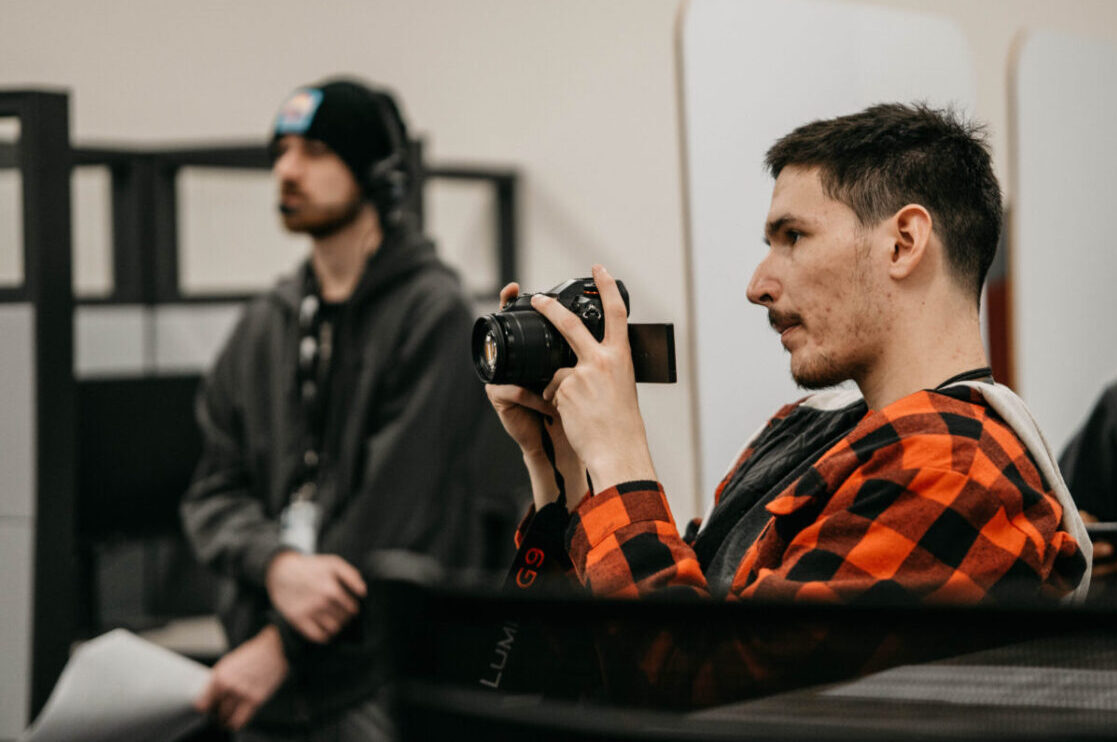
[[472, 278, 676, 391]]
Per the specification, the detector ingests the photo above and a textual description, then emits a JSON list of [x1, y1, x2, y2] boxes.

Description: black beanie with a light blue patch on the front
[[269, 79, 407, 194]]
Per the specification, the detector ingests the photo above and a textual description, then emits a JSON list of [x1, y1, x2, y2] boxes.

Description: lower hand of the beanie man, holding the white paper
[[194, 626, 290, 730]]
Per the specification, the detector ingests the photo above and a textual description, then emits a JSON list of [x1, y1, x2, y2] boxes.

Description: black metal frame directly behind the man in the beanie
[[67, 142, 518, 305]]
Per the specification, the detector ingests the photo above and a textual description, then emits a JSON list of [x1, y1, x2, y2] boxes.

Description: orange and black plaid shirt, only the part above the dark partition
[[567, 387, 1086, 602]]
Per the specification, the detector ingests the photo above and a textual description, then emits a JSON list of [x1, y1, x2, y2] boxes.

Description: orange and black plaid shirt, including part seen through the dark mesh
[[516, 387, 1086, 706]]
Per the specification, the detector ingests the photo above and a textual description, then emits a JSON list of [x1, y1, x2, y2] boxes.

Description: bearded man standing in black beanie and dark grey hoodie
[[182, 79, 521, 740]]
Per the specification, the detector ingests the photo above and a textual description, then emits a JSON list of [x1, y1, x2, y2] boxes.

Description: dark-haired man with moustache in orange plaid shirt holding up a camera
[[487, 104, 1090, 703]]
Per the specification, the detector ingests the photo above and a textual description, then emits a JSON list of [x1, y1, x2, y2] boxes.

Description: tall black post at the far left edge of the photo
[[0, 91, 76, 716]]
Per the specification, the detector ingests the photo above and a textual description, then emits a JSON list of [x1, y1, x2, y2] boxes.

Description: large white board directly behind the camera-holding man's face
[[681, 0, 975, 498]]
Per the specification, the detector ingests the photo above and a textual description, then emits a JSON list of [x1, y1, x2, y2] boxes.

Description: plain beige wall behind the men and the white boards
[[0, 0, 1117, 527]]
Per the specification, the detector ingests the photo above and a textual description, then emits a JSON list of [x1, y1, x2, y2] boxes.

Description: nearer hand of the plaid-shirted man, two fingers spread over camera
[[532, 266, 656, 492]]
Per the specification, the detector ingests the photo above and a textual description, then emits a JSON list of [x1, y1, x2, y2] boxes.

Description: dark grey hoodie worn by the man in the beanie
[[182, 230, 528, 722]]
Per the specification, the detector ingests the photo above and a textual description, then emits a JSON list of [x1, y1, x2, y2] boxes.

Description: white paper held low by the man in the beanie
[[20, 629, 210, 742]]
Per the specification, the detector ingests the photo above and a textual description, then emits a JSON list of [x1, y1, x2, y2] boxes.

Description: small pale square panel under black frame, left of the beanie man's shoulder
[[74, 306, 151, 378]]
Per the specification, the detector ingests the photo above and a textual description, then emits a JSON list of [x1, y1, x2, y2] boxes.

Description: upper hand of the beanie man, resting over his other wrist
[[266, 551, 367, 644]]
